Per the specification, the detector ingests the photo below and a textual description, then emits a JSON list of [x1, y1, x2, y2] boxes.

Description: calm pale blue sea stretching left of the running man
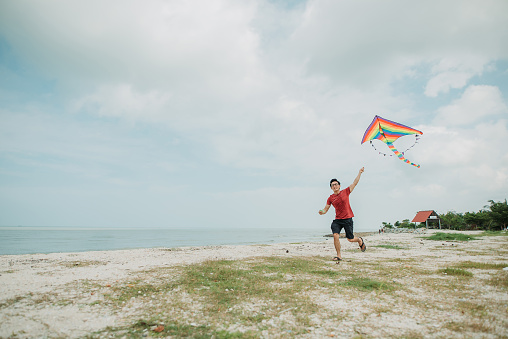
[[0, 226, 326, 255]]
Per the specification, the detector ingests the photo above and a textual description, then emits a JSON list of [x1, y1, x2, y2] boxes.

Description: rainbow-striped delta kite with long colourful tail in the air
[[362, 115, 423, 168]]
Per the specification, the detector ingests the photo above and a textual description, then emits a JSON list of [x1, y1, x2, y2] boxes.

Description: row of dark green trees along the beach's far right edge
[[383, 199, 508, 231]]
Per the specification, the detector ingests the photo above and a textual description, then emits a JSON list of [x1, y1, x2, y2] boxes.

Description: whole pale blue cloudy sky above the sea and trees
[[0, 0, 508, 231]]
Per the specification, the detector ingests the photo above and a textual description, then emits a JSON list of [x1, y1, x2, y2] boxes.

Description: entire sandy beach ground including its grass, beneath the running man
[[0, 230, 508, 338]]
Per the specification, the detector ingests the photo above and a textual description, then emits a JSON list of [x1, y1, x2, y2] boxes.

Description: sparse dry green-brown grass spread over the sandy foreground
[[77, 257, 505, 338]]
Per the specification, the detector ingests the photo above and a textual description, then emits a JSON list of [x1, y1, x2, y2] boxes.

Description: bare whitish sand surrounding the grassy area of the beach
[[0, 232, 508, 338]]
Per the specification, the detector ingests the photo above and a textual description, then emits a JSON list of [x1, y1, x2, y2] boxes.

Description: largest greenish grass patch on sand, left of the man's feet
[[110, 257, 330, 312]]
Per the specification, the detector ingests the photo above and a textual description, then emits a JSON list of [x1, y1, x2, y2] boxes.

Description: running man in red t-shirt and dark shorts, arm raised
[[319, 167, 367, 263]]
